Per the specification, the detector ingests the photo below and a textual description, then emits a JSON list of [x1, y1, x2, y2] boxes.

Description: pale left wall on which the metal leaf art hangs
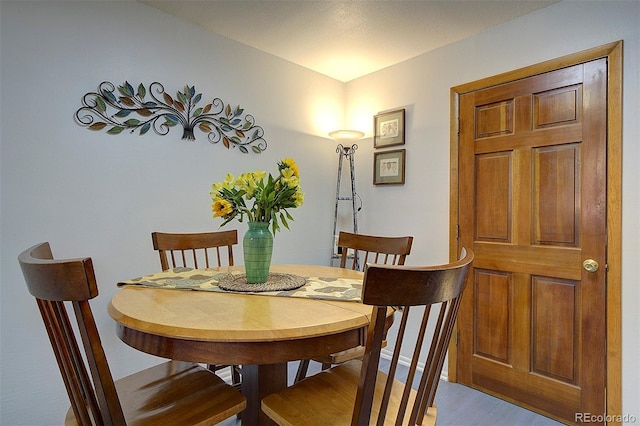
[[0, 1, 345, 425]]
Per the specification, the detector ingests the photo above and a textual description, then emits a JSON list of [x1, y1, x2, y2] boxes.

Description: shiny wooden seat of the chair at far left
[[65, 361, 246, 426]]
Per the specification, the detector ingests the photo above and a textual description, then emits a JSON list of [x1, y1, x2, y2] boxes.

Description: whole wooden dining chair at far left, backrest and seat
[[18, 243, 246, 426]]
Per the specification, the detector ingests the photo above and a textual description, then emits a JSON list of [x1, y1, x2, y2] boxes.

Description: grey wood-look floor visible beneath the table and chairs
[[220, 359, 562, 426]]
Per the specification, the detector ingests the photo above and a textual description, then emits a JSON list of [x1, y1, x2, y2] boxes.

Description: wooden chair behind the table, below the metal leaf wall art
[[151, 229, 242, 386]]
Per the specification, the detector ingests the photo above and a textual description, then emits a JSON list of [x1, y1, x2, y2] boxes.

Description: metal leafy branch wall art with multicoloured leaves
[[75, 81, 267, 154]]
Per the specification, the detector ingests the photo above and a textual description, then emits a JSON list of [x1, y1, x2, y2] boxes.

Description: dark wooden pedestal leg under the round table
[[241, 362, 287, 426]]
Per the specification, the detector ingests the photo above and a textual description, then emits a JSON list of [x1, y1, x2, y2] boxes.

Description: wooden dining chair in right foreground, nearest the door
[[262, 249, 473, 426]]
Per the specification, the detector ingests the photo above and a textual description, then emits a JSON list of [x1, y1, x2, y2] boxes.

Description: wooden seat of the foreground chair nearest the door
[[262, 360, 437, 426]]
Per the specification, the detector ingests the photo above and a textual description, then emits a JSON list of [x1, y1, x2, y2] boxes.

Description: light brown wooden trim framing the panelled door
[[448, 40, 623, 424]]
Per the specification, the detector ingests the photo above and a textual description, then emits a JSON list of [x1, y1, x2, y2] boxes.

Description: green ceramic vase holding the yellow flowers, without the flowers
[[242, 222, 273, 284]]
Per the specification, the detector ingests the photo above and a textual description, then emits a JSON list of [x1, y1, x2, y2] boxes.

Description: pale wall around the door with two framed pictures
[[347, 1, 640, 419]]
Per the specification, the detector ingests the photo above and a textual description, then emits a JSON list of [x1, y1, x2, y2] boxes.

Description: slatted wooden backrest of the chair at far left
[[18, 243, 125, 425]]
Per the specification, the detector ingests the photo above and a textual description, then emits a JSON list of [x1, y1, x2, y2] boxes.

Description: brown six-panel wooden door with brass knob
[[457, 58, 607, 423]]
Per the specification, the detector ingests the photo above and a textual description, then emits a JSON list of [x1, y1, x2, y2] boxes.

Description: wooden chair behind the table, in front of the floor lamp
[[295, 231, 413, 382]]
